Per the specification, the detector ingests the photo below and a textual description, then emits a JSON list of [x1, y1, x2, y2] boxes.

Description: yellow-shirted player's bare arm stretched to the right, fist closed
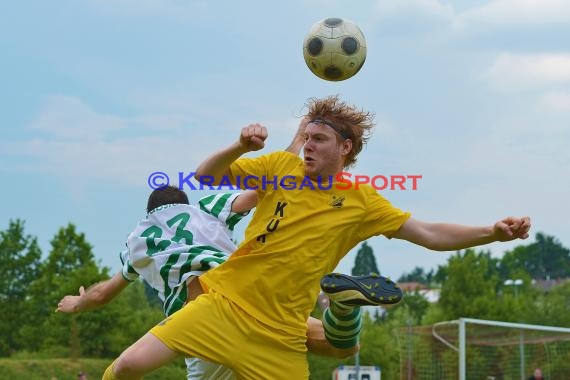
[[392, 217, 531, 251]]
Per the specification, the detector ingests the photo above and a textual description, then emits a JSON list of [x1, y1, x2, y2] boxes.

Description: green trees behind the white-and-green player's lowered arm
[[14, 224, 163, 358]]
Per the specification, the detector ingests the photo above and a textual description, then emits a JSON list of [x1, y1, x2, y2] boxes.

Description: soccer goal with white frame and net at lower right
[[398, 318, 570, 380]]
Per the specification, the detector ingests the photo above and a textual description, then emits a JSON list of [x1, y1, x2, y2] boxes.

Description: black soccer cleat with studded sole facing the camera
[[321, 273, 403, 306]]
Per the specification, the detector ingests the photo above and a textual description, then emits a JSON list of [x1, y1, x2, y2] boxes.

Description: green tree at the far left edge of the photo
[[0, 219, 41, 356]]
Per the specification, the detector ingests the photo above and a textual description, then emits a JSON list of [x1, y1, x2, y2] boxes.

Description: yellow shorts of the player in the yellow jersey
[[150, 290, 309, 380]]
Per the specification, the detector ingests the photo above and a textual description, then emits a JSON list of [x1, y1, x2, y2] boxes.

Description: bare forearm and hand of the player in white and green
[[55, 272, 130, 313]]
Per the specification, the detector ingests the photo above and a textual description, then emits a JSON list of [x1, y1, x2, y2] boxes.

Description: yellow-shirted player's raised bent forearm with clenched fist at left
[[194, 124, 267, 185]]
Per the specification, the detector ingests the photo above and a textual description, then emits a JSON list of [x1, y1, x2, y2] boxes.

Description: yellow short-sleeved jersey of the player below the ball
[[201, 152, 410, 336]]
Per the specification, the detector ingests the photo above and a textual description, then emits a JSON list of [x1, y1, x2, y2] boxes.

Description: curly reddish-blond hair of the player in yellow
[[305, 95, 374, 168]]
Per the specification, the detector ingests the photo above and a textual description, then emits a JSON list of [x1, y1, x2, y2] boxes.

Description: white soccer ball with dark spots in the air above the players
[[303, 18, 366, 81]]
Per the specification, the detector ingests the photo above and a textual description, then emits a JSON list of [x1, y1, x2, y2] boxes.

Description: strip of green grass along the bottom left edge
[[0, 359, 186, 380]]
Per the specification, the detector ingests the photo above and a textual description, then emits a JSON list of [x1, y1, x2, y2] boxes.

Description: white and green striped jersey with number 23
[[121, 193, 245, 315]]
